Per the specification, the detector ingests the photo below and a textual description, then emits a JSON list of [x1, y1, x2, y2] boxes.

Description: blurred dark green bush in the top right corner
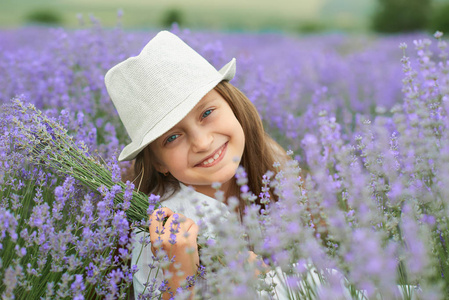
[[372, 0, 449, 33]]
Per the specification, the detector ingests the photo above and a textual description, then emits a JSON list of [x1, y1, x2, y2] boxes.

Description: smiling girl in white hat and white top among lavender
[[105, 31, 286, 298]]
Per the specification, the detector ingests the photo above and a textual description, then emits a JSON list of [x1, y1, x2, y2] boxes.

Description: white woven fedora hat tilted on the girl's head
[[105, 31, 235, 161]]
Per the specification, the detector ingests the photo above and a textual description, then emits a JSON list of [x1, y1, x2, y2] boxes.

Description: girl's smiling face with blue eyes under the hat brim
[[150, 90, 245, 197]]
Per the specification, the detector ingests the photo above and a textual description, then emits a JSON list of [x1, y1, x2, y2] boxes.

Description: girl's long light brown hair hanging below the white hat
[[134, 81, 288, 214]]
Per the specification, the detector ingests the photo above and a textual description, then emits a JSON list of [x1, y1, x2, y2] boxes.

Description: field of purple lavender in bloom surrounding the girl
[[0, 19, 449, 299]]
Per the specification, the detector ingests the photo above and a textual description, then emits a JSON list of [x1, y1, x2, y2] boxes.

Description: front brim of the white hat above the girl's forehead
[[118, 58, 236, 161]]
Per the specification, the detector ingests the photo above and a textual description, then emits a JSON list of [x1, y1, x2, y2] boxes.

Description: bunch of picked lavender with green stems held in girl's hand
[[11, 99, 155, 222]]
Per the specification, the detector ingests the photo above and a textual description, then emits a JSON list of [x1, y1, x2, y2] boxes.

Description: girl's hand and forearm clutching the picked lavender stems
[[150, 207, 199, 291]]
